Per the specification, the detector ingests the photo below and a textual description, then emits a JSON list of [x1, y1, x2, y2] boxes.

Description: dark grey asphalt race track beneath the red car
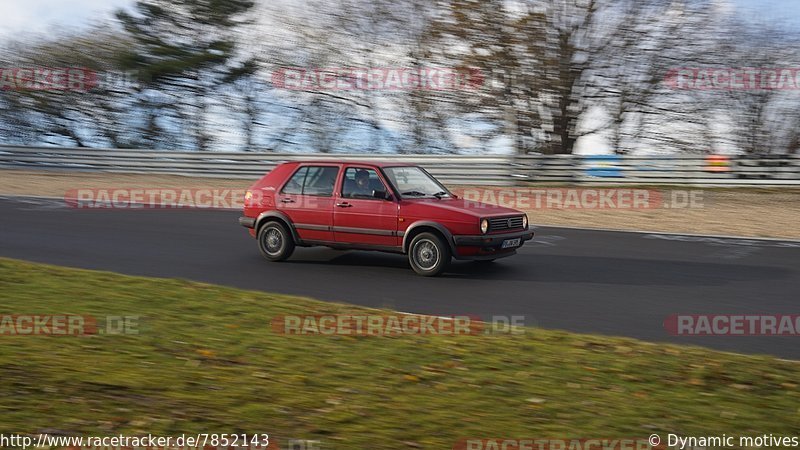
[[0, 198, 800, 359]]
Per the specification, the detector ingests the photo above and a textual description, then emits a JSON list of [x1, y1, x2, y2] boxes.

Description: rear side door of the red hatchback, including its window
[[275, 164, 339, 242]]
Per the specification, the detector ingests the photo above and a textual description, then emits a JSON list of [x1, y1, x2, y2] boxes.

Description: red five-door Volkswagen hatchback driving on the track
[[239, 161, 533, 276]]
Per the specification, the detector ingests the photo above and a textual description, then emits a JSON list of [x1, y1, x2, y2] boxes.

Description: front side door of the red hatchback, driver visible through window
[[333, 165, 400, 247]]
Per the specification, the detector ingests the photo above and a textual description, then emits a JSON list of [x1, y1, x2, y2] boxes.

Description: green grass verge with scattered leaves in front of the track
[[0, 259, 800, 449]]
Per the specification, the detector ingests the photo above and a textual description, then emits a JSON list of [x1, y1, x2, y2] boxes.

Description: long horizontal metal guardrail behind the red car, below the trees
[[0, 146, 800, 186]]
